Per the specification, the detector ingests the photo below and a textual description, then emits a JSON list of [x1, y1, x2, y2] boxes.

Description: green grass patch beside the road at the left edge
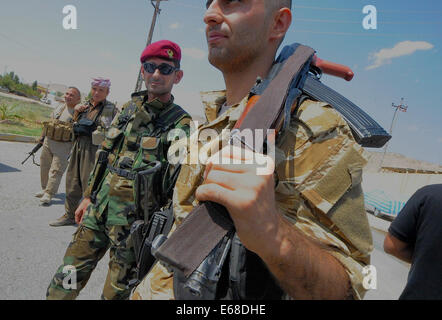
[[0, 97, 53, 137]]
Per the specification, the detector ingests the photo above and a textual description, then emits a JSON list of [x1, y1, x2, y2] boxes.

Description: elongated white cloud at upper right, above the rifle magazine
[[365, 40, 434, 70]]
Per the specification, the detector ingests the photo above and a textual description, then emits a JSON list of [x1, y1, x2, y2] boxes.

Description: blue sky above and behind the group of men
[[0, 0, 442, 164]]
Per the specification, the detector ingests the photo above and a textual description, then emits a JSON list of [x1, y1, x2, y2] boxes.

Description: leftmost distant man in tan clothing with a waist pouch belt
[[35, 87, 81, 205]]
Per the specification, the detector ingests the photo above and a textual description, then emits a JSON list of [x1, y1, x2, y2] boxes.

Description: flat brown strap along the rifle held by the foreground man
[[156, 45, 314, 277]]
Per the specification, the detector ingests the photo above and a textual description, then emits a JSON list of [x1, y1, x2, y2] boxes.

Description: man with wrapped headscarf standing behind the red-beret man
[[49, 78, 117, 227]]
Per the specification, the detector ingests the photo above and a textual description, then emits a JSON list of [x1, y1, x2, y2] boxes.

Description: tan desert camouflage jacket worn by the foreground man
[[132, 92, 372, 300]]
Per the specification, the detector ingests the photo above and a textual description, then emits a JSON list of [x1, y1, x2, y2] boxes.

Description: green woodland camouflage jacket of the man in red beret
[[83, 91, 190, 229]]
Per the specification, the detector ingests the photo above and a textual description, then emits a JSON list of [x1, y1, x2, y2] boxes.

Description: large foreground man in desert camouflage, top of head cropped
[[132, 0, 372, 300]]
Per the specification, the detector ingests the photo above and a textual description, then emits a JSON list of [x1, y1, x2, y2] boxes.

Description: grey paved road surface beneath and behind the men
[[0, 141, 408, 300]]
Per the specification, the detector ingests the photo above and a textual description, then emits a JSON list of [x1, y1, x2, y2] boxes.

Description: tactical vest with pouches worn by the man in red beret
[[102, 92, 188, 212]]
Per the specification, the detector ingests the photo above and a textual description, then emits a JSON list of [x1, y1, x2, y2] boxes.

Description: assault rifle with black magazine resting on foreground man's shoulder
[[155, 44, 391, 298]]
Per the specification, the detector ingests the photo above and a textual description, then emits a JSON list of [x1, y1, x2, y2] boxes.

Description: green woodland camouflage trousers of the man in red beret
[[46, 205, 136, 300]]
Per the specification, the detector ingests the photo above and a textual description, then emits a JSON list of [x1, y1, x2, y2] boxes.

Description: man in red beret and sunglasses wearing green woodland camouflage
[[47, 40, 190, 299]]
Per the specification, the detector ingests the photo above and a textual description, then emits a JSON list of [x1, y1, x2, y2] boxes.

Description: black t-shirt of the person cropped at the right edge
[[388, 184, 442, 300]]
